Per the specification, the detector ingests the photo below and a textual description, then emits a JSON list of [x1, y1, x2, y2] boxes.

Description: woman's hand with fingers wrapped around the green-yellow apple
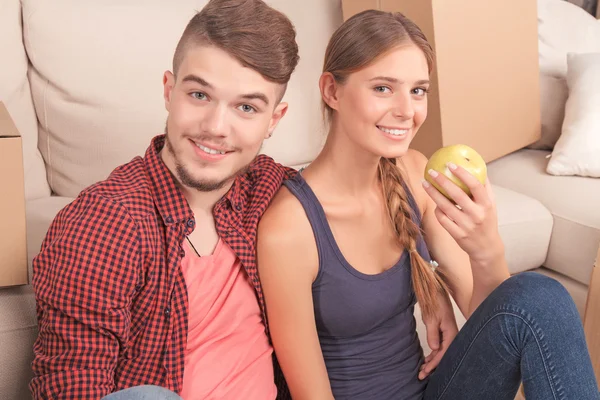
[[423, 163, 504, 264]]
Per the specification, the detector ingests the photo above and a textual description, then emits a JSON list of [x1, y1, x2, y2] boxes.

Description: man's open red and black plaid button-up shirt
[[30, 135, 294, 400]]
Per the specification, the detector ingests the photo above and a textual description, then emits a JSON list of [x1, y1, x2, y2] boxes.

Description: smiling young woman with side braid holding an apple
[[258, 10, 598, 400]]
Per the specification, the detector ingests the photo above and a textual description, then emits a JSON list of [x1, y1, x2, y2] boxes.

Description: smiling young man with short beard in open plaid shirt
[[30, 0, 298, 400]]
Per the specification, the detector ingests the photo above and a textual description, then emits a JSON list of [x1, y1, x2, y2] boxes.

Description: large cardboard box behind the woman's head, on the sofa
[[342, 0, 541, 162]]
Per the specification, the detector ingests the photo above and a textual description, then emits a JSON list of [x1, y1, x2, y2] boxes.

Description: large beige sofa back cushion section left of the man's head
[[22, 0, 198, 197]]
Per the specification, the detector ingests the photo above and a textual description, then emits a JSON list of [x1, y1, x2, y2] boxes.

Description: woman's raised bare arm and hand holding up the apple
[[403, 151, 510, 318]]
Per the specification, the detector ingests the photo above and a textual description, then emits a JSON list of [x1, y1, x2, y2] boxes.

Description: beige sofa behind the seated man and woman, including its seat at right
[[0, 0, 600, 400]]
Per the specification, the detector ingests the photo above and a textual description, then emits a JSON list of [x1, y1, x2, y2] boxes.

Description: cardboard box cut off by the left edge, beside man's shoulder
[[0, 102, 28, 287]]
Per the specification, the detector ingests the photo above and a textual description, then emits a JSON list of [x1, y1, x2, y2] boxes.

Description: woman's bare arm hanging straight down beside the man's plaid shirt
[[257, 187, 333, 400]]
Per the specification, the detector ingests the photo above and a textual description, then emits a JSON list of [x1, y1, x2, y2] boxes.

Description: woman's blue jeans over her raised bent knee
[[424, 272, 600, 400]]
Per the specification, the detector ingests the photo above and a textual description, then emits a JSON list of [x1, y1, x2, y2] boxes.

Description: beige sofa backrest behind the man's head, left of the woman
[[0, 0, 342, 200]]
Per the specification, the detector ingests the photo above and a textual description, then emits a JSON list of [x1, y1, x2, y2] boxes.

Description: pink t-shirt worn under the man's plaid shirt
[[181, 239, 277, 400]]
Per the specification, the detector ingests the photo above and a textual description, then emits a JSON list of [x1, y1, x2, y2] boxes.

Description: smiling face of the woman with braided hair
[[334, 44, 429, 158]]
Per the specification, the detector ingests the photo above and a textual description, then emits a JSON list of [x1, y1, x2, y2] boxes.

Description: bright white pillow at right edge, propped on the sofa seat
[[547, 52, 600, 177]]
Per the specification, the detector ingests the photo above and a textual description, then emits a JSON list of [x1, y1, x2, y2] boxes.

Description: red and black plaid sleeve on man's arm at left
[[30, 194, 140, 399]]
